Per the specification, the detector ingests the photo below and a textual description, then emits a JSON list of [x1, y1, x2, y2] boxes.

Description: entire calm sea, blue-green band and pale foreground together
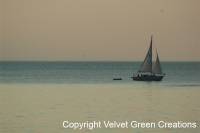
[[0, 62, 200, 133]]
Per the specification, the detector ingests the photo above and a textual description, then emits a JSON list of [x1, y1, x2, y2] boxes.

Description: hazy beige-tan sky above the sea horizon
[[0, 0, 200, 61]]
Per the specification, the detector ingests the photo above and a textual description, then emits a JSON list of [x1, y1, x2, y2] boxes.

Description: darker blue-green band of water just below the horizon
[[0, 62, 200, 86]]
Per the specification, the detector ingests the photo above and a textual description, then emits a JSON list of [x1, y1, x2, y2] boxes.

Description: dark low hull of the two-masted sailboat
[[132, 75, 164, 81]]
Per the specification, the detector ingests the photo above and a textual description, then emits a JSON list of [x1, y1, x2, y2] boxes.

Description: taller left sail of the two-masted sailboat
[[139, 37, 152, 73]]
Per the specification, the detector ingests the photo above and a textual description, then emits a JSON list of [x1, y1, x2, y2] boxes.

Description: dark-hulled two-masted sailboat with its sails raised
[[132, 36, 165, 81]]
